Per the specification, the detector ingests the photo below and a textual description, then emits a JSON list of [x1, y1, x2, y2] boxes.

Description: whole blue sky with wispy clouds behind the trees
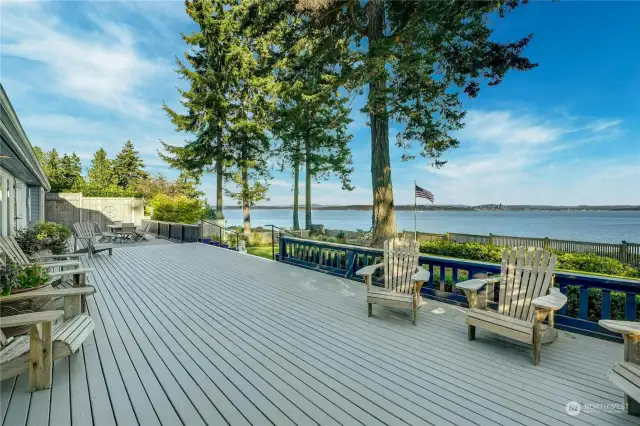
[[0, 1, 640, 205]]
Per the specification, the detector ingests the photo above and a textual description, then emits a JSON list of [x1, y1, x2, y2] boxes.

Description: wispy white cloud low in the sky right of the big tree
[[425, 111, 640, 205]]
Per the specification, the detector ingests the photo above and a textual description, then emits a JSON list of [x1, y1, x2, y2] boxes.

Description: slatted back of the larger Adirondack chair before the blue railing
[[498, 247, 557, 322]]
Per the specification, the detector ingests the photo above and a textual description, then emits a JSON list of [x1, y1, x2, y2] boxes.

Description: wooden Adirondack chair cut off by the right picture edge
[[598, 320, 640, 416]]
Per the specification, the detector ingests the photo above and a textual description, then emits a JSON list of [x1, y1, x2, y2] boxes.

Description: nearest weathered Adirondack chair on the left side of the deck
[[0, 286, 95, 392]]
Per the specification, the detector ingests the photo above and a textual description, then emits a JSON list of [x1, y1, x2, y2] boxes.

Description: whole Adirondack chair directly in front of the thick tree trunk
[[356, 238, 429, 325]]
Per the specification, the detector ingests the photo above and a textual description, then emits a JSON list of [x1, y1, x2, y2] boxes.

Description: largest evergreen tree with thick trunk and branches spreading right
[[251, 0, 536, 245]]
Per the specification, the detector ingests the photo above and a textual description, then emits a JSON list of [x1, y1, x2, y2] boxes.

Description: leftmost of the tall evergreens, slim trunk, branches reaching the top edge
[[160, 0, 237, 217]]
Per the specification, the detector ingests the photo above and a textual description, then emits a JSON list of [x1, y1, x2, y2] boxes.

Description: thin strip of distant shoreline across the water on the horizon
[[225, 204, 640, 212]]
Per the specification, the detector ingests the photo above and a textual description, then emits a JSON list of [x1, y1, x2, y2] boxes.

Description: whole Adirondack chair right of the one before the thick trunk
[[456, 247, 567, 365]]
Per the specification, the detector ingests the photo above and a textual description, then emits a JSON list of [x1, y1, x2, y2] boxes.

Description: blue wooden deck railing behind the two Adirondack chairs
[[278, 236, 640, 341]]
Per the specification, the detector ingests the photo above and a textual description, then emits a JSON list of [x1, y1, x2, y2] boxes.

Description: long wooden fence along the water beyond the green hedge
[[401, 231, 640, 266]]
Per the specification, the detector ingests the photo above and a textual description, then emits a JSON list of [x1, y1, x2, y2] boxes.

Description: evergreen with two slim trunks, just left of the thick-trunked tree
[[274, 43, 353, 229]]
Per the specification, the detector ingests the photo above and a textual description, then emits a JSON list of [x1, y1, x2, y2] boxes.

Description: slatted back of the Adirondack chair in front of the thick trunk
[[384, 238, 419, 294]]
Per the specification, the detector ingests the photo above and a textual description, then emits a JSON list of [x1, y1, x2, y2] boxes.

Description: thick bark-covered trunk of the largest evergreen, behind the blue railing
[[367, 0, 396, 247]]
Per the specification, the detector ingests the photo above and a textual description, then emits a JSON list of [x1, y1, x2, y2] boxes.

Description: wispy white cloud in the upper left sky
[[2, 3, 168, 115]]
